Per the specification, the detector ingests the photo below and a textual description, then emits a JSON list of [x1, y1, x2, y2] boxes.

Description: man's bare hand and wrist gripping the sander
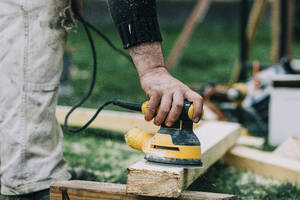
[[129, 42, 203, 126]]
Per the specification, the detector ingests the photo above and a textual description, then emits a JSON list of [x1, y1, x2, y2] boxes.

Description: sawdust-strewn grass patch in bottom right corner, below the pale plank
[[189, 163, 300, 200]]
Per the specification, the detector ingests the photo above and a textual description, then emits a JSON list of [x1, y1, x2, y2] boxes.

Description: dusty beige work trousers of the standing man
[[0, 0, 74, 195]]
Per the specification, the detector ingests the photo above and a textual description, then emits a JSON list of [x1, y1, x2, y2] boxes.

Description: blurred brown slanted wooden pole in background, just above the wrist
[[167, 0, 211, 71]]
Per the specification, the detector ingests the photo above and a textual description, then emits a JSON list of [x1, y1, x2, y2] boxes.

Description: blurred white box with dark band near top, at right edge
[[269, 75, 300, 145]]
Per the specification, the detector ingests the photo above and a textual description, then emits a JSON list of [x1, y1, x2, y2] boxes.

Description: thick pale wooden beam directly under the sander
[[127, 121, 241, 198]]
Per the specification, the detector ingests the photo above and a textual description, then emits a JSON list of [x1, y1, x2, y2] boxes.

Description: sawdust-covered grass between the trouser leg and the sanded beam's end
[[64, 129, 143, 183]]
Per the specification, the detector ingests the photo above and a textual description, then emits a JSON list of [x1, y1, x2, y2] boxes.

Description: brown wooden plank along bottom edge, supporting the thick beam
[[50, 181, 236, 200]]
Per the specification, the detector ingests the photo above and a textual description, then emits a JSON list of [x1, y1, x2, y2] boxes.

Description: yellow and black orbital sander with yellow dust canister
[[113, 100, 203, 167]]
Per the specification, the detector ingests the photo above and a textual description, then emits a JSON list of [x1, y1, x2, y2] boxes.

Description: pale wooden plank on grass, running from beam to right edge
[[223, 146, 300, 186]]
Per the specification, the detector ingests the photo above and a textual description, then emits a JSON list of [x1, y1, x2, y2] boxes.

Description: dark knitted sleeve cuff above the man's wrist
[[108, 0, 162, 48]]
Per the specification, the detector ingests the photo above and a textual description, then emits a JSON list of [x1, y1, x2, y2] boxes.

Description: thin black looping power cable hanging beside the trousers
[[64, 11, 132, 133]]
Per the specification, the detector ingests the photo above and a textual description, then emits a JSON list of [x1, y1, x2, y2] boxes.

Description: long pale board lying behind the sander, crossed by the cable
[[56, 106, 217, 133]]
